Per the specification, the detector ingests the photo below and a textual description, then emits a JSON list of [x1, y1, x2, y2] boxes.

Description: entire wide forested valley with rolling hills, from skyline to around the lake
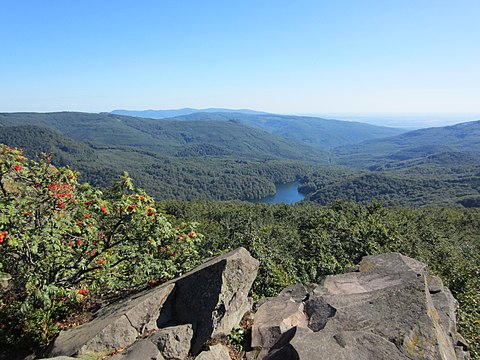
[[0, 109, 480, 207]]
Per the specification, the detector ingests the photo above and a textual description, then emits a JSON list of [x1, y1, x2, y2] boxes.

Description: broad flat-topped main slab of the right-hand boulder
[[311, 253, 455, 360]]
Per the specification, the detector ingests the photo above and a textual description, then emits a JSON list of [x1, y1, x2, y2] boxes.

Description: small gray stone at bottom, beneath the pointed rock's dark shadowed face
[[149, 324, 193, 360]]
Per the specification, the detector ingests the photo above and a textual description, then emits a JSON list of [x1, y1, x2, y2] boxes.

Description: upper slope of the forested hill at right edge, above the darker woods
[[335, 121, 480, 167]]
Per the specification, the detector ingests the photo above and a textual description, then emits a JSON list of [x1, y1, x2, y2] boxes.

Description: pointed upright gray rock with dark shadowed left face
[[159, 248, 259, 355]]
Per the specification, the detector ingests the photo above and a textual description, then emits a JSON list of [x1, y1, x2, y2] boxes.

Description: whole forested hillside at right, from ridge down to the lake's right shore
[[292, 121, 480, 207]]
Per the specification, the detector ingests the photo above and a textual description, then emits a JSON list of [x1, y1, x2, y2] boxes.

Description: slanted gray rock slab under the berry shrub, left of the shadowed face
[[46, 284, 175, 357]]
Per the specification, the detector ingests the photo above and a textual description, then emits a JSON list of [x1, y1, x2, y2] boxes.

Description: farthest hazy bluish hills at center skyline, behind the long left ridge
[[109, 109, 405, 149]]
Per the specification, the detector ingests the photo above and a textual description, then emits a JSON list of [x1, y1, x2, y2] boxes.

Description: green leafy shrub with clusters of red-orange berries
[[0, 145, 201, 348]]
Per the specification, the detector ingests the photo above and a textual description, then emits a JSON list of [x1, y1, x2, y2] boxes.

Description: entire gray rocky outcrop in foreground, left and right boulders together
[[41, 252, 469, 360]]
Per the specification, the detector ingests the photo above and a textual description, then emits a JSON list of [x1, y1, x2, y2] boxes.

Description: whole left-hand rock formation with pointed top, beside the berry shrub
[[42, 248, 259, 359]]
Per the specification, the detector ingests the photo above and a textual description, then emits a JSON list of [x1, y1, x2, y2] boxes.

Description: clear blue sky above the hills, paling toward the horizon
[[0, 0, 480, 114]]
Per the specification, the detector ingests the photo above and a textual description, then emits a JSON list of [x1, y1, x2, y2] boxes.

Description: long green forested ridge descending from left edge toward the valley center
[[0, 112, 328, 163]]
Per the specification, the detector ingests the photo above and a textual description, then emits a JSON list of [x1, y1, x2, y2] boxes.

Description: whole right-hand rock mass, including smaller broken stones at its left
[[252, 253, 468, 360]]
